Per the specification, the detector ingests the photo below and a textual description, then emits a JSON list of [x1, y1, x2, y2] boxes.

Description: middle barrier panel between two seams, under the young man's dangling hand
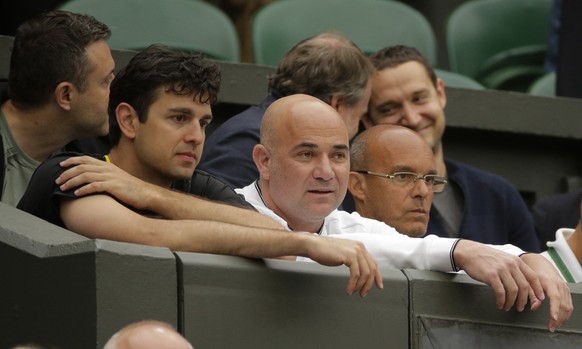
[[177, 253, 408, 349]]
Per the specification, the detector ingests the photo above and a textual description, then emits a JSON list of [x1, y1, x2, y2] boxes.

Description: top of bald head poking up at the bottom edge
[[103, 321, 193, 349]]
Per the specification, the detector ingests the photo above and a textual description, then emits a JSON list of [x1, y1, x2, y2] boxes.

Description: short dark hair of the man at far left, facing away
[[8, 11, 111, 108]]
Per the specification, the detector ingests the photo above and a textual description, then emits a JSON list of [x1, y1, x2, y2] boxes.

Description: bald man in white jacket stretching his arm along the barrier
[[237, 95, 572, 331]]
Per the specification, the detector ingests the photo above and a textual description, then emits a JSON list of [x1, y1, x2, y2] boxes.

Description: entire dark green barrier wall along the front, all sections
[[0, 204, 582, 349]]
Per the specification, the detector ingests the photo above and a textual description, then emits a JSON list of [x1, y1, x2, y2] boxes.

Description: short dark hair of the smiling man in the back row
[[370, 45, 437, 87]]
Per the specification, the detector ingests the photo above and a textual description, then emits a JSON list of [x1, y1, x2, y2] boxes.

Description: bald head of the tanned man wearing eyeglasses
[[348, 125, 437, 236]]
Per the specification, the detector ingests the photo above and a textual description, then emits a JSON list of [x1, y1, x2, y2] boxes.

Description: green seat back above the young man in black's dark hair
[[59, 0, 240, 62]]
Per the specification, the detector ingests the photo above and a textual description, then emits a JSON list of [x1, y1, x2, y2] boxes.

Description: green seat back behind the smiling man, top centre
[[252, 0, 437, 66]]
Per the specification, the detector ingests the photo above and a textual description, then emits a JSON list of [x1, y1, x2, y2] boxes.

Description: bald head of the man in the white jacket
[[253, 95, 349, 232]]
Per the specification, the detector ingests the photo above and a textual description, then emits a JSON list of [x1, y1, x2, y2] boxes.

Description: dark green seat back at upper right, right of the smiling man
[[446, 0, 552, 89]]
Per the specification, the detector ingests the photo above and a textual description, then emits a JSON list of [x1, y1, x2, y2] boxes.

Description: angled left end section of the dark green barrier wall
[[0, 203, 178, 349]]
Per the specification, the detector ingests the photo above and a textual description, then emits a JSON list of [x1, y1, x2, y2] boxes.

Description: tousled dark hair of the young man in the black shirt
[[109, 45, 220, 146]]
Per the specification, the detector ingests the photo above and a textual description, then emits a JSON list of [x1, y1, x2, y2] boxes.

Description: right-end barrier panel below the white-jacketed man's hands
[[404, 270, 582, 349]]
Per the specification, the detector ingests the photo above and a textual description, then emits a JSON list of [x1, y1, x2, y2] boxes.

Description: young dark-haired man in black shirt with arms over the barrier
[[18, 46, 382, 295]]
